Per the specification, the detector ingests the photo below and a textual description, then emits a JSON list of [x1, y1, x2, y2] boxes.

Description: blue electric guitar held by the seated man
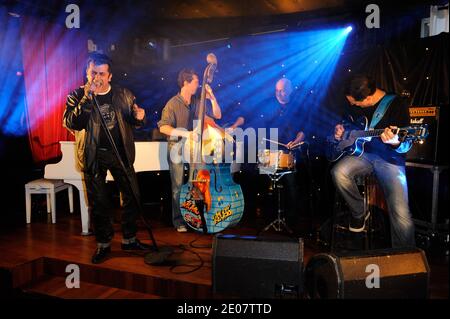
[[326, 117, 428, 162]]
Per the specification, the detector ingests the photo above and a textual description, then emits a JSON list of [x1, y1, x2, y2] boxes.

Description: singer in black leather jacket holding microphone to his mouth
[[63, 53, 150, 264]]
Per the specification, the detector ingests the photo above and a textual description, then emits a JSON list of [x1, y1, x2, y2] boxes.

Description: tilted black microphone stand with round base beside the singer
[[92, 94, 174, 265]]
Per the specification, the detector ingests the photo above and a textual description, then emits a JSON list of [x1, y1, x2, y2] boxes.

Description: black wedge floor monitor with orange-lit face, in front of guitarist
[[305, 248, 430, 299]]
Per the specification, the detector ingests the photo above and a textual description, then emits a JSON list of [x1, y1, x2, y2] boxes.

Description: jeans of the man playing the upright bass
[[167, 142, 186, 228]]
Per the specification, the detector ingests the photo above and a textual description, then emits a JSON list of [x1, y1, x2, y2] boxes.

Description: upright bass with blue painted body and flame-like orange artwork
[[180, 53, 244, 233]]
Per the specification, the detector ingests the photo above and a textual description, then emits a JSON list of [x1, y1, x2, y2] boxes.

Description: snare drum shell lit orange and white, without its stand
[[258, 149, 295, 172]]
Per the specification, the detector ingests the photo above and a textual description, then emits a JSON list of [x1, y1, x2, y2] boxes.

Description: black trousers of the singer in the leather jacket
[[84, 149, 140, 244]]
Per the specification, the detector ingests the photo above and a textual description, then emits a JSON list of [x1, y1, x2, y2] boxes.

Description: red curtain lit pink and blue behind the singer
[[20, 17, 87, 163]]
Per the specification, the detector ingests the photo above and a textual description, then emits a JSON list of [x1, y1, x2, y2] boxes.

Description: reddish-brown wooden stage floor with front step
[[0, 214, 448, 299]]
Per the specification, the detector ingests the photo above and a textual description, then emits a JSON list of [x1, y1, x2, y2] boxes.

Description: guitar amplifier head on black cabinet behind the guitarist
[[406, 106, 449, 164]]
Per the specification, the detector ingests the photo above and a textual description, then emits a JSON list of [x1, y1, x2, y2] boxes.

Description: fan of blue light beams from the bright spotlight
[[197, 26, 350, 135]]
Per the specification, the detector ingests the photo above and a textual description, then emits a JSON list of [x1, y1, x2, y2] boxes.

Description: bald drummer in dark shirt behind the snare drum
[[258, 78, 305, 226]]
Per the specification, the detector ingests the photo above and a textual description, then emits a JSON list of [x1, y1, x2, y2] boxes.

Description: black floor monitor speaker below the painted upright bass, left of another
[[212, 234, 303, 299]]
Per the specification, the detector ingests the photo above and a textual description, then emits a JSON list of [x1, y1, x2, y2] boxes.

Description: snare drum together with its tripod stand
[[258, 139, 304, 233]]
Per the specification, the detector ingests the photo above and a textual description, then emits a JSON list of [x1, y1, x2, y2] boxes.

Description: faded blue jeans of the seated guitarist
[[331, 153, 415, 247]]
